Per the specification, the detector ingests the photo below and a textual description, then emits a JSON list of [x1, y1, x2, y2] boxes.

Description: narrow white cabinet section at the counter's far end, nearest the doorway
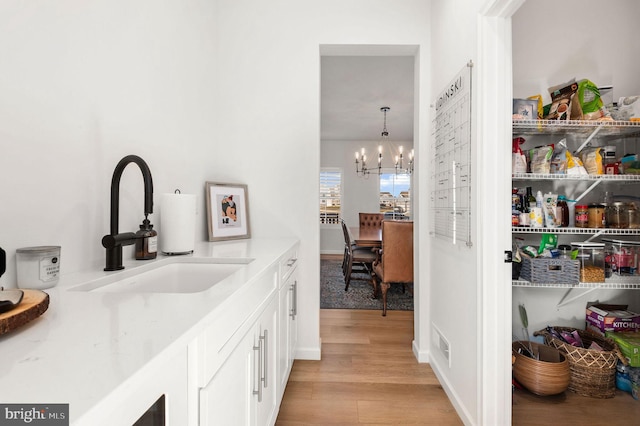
[[278, 249, 298, 404]]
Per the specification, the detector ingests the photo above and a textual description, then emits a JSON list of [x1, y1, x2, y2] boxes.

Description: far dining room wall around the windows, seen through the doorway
[[320, 141, 413, 254]]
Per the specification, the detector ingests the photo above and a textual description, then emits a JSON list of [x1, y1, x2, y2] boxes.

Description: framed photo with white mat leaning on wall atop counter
[[205, 182, 251, 241]]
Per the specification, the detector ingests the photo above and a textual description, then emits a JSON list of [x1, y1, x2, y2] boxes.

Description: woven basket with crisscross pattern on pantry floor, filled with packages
[[533, 327, 626, 398]]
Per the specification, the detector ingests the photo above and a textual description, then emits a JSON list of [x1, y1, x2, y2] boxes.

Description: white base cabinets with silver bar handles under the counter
[[190, 245, 298, 426]]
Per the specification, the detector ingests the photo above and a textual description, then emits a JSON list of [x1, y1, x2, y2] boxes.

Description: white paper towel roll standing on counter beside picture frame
[[158, 194, 196, 254]]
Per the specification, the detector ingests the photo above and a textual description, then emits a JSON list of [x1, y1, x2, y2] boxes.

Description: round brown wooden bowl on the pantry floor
[[511, 341, 571, 396]]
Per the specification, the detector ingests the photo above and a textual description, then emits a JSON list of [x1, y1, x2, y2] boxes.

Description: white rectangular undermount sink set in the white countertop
[[70, 258, 253, 293]]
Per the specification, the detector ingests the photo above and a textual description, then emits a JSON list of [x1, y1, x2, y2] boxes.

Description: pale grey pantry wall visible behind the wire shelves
[[512, 0, 640, 338]]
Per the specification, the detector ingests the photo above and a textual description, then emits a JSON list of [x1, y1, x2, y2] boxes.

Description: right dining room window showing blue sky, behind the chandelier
[[380, 173, 411, 219]]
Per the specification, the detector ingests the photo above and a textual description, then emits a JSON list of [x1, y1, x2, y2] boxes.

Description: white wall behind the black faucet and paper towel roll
[[0, 0, 219, 276]]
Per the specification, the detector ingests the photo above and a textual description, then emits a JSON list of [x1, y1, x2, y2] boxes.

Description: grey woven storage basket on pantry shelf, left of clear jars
[[520, 258, 580, 284]]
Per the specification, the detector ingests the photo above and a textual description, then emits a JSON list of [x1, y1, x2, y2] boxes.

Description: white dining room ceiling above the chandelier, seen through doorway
[[320, 56, 414, 141]]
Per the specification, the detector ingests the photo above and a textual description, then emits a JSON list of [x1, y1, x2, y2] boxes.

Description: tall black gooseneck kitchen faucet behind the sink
[[102, 155, 153, 271]]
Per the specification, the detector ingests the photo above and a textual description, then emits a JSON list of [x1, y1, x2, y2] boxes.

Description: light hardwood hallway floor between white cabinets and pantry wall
[[276, 309, 462, 426]]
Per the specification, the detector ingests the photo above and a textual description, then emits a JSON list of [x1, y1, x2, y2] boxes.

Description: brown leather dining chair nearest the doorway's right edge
[[372, 220, 413, 316]]
